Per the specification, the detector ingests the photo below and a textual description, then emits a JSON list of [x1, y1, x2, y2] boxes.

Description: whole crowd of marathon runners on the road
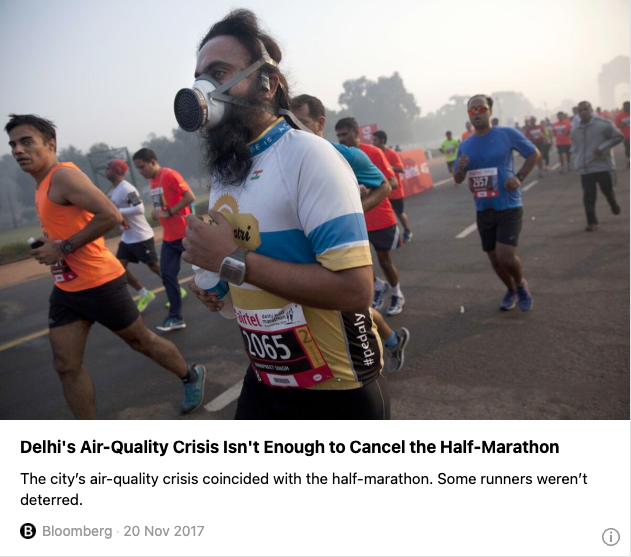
[[5, 10, 629, 419]]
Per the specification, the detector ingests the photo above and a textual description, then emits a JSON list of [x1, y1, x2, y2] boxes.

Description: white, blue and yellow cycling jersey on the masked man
[[209, 119, 382, 389]]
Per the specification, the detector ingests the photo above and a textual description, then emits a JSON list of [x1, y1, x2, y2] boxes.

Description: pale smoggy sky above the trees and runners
[[0, 0, 631, 155]]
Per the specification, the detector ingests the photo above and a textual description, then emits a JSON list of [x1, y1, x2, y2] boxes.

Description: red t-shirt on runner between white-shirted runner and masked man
[[149, 167, 191, 242]]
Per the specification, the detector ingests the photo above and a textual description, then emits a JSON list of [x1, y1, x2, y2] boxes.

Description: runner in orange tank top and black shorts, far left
[[5, 114, 206, 419]]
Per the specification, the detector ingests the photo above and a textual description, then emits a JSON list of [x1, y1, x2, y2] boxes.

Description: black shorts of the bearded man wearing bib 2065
[[234, 366, 390, 420]]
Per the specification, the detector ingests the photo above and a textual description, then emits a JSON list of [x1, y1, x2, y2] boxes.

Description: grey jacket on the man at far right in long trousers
[[571, 116, 623, 174]]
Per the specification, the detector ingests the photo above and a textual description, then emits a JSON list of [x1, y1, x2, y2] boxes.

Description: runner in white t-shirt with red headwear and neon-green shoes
[[105, 159, 160, 313]]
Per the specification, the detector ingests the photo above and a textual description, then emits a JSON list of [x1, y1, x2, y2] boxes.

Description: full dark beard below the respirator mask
[[200, 91, 264, 186]]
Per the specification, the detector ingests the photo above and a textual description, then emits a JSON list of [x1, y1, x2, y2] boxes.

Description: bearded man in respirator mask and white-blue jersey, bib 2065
[[175, 10, 390, 419]]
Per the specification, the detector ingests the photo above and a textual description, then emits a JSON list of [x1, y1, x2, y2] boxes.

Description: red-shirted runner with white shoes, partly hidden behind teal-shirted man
[[335, 118, 405, 315]]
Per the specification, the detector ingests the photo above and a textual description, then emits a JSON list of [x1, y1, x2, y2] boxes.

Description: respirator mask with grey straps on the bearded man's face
[[173, 45, 311, 132]]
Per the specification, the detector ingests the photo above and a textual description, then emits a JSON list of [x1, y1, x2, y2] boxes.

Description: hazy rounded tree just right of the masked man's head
[[336, 72, 421, 143]]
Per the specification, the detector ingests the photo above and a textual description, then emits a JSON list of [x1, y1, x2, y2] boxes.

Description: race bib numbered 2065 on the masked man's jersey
[[234, 303, 333, 389]]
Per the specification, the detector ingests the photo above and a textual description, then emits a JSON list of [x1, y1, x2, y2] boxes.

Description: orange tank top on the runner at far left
[[35, 162, 125, 292]]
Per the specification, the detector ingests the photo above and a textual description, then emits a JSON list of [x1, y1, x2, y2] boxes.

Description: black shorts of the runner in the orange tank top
[[48, 274, 140, 331]]
